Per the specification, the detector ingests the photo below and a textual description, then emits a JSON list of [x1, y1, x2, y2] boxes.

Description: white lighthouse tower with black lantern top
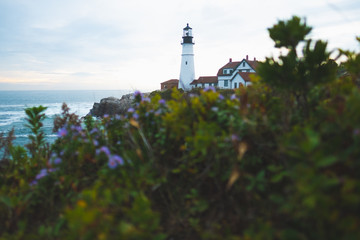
[[178, 24, 195, 90]]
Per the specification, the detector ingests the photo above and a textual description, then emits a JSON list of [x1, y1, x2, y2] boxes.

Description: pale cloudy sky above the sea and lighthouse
[[0, 0, 360, 91]]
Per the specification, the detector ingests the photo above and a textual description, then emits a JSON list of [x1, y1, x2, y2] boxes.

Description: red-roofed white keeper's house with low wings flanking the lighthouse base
[[161, 56, 258, 89]]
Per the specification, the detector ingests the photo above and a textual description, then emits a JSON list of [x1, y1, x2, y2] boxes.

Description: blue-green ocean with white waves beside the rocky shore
[[0, 90, 133, 145]]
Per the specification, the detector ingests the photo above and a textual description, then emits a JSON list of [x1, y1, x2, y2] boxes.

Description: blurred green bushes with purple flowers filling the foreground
[[0, 17, 360, 240]]
